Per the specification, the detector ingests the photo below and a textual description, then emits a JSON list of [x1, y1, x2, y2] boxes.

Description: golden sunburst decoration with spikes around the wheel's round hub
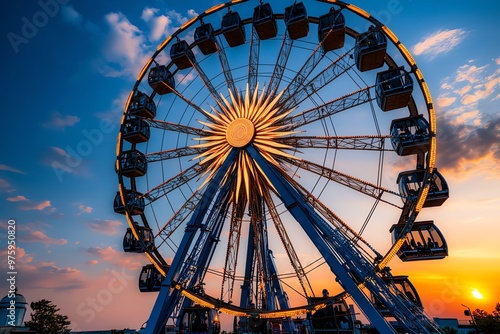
[[193, 84, 294, 201]]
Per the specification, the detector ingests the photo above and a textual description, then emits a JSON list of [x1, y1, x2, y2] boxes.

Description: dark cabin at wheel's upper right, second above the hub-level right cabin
[[354, 27, 387, 72]]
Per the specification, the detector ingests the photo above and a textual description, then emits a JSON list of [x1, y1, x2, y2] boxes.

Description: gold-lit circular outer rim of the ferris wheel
[[115, 0, 436, 288]]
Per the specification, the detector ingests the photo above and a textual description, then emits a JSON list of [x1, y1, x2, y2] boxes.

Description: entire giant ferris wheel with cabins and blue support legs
[[114, 0, 448, 333]]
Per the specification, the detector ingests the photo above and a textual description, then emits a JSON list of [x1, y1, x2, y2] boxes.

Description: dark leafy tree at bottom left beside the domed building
[[24, 299, 71, 334]]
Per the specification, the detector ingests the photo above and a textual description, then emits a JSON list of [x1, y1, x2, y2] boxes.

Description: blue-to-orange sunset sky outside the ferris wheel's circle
[[0, 0, 500, 329]]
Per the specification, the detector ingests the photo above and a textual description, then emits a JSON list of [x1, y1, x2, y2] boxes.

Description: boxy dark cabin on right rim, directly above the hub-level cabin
[[375, 67, 413, 111]]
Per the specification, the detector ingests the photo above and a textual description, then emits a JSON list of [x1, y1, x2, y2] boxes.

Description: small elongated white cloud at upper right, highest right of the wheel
[[413, 29, 467, 58]]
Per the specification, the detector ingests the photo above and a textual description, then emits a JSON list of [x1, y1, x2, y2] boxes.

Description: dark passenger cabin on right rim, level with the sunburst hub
[[391, 115, 431, 156]]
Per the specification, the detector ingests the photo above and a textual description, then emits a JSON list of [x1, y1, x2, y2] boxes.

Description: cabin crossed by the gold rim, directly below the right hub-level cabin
[[397, 168, 449, 207]]
